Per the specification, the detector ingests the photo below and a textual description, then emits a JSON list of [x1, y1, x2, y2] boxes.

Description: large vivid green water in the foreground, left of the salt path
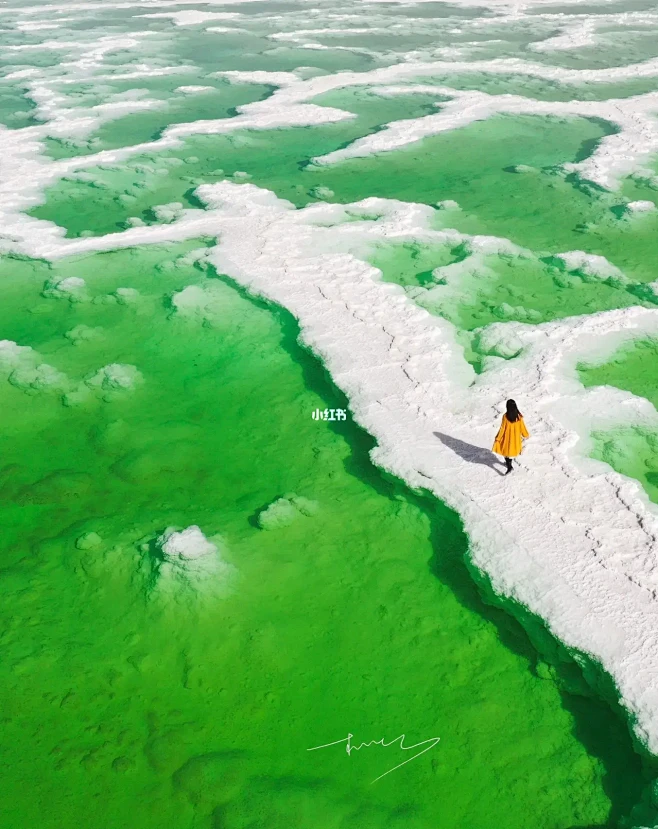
[[0, 241, 644, 829]]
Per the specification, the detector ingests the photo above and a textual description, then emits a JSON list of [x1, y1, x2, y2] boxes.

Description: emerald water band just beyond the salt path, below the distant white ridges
[[31, 102, 658, 290]]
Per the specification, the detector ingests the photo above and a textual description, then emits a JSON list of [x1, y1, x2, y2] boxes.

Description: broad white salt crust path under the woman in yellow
[[9, 182, 658, 753]]
